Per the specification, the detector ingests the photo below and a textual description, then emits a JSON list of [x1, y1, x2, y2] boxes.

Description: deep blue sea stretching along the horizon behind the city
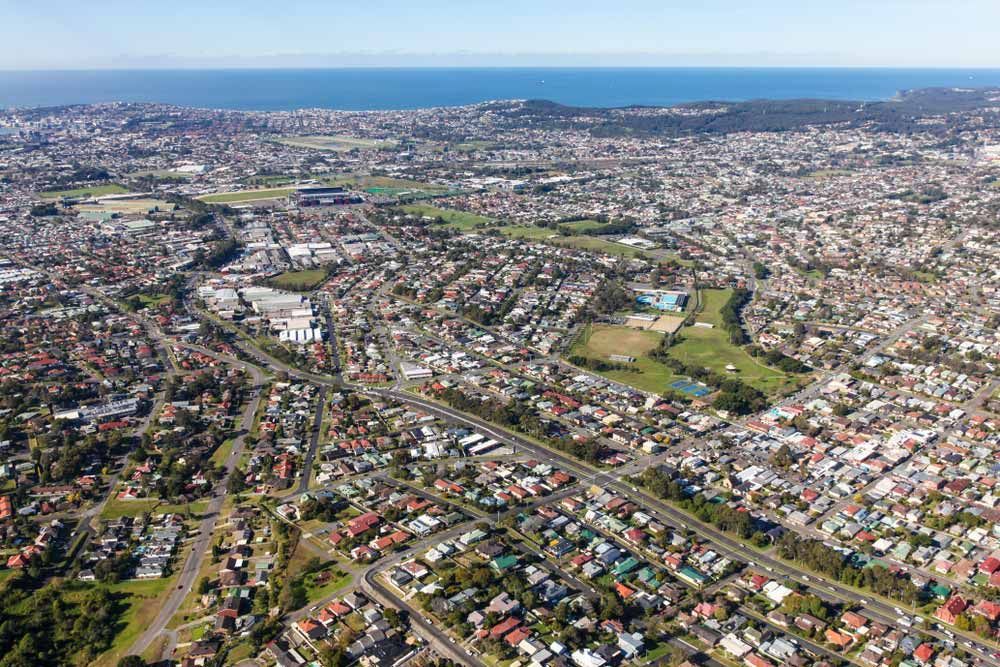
[[0, 68, 1000, 111]]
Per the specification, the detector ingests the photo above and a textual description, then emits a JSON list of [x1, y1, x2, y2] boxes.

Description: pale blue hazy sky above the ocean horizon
[[0, 0, 1000, 69]]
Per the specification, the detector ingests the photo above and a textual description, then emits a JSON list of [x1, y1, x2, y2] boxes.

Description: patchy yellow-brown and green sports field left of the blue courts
[[567, 324, 678, 394]]
